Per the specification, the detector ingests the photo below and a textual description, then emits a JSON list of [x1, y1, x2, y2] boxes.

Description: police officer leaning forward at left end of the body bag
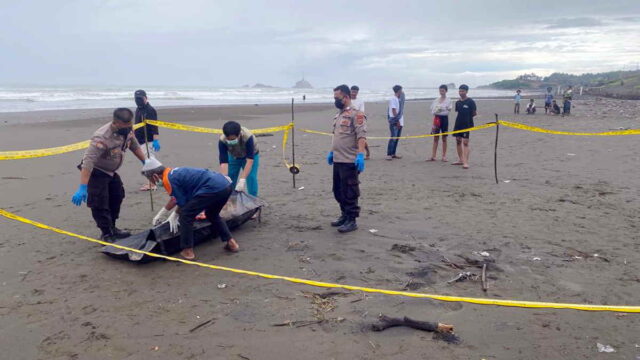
[[71, 108, 146, 242]]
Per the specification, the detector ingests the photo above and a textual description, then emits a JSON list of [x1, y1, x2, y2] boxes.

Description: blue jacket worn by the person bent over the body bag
[[167, 167, 231, 207]]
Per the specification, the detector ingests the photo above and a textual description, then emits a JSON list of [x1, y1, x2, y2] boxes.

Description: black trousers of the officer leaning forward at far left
[[87, 169, 124, 235]]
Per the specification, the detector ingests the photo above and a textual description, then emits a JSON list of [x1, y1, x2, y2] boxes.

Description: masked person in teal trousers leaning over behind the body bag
[[218, 121, 260, 196]]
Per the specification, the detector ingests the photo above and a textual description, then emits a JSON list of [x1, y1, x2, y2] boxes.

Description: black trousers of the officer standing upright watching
[[333, 163, 360, 219]]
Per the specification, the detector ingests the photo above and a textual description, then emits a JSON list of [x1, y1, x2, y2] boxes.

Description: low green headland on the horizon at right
[[479, 70, 640, 100]]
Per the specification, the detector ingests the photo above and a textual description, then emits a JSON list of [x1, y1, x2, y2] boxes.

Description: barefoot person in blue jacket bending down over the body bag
[[142, 158, 240, 260]]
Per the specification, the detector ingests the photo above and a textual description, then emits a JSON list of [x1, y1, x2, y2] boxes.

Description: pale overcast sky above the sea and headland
[[0, 0, 640, 87]]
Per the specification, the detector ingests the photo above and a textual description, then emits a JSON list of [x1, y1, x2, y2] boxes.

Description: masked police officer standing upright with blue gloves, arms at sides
[[327, 85, 367, 233]]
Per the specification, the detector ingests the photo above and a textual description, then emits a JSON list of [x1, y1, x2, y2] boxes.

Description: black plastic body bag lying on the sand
[[102, 191, 267, 262]]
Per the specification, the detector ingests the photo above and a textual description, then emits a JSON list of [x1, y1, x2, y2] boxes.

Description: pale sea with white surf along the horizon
[[0, 87, 513, 112]]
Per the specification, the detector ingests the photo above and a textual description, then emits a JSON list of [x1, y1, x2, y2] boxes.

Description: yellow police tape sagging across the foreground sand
[[0, 209, 640, 313]]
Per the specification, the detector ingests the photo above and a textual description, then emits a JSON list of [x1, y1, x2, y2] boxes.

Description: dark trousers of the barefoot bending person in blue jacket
[[180, 186, 232, 249]]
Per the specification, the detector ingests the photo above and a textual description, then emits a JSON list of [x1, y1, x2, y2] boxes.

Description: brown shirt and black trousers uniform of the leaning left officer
[[79, 123, 140, 235]]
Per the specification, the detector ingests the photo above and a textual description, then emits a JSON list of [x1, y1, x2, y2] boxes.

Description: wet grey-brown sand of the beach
[[0, 94, 640, 360]]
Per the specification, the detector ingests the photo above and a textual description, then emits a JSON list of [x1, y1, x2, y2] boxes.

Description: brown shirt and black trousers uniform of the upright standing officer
[[331, 107, 367, 219]]
